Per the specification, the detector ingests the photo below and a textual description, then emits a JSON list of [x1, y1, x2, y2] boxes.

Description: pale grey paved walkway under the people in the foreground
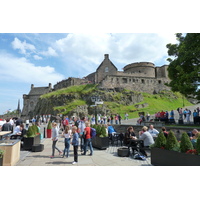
[[16, 138, 151, 166]]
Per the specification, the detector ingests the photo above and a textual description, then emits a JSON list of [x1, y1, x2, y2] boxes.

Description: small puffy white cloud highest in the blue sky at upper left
[[11, 38, 35, 54]]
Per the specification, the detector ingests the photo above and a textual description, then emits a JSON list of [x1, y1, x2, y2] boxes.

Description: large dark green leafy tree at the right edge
[[166, 33, 200, 100]]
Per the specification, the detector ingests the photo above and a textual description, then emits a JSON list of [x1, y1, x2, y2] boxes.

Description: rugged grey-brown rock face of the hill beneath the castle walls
[[31, 89, 143, 117]]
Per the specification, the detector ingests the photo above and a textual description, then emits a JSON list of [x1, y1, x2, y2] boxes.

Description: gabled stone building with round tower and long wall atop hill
[[86, 54, 169, 94]]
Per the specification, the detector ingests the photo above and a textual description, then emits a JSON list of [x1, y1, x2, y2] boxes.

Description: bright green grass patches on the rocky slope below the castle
[[41, 84, 192, 118]]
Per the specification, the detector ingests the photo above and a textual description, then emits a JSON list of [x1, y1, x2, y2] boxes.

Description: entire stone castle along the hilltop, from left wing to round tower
[[22, 54, 169, 116]]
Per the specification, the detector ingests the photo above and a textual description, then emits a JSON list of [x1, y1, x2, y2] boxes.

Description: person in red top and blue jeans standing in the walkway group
[[82, 122, 93, 156]]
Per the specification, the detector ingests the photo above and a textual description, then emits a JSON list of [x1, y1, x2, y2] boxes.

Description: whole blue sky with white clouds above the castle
[[0, 33, 176, 114]]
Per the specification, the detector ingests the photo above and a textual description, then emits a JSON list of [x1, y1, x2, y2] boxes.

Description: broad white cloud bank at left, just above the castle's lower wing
[[0, 53, 64, 85]]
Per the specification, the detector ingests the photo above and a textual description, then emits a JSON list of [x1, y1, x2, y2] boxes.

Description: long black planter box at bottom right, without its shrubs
[[151, 148, 200, 166]]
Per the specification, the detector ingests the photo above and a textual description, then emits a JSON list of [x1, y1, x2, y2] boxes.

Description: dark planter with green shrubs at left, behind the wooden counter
[[23, 125, 40, 150]]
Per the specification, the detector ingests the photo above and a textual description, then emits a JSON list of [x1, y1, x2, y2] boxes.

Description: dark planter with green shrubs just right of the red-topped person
[[92, 124, 109, 149]]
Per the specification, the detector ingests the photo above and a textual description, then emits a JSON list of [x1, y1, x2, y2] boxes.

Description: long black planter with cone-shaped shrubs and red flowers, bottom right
[[151, 131, 200, 166]]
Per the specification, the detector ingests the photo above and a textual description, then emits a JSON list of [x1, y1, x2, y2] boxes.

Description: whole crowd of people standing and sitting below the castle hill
[[0, 108, 200, 164]]
